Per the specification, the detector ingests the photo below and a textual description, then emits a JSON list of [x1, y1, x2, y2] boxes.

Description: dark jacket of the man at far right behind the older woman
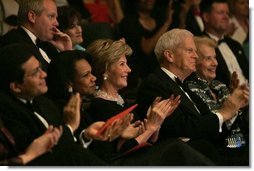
[[205, 34, 249, 86]]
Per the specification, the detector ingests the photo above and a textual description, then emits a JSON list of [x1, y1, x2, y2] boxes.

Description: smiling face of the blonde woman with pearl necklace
[[107, 55, 131, 90]]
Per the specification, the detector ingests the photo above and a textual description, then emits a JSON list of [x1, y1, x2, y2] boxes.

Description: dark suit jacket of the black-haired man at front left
[[0, 91, 107, 165]]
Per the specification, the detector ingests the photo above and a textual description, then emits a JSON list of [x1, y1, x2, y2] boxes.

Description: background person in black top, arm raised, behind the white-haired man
[[119, 0, 173, 95]]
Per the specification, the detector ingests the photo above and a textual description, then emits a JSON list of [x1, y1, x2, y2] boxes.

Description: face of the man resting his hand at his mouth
[[34, 0, 58, 41]]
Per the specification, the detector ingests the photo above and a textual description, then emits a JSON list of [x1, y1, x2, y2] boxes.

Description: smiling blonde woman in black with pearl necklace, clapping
[[87, 39, 216, 165]]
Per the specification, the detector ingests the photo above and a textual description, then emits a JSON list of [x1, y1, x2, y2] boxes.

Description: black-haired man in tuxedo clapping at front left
[[0, 44, 107, 166]]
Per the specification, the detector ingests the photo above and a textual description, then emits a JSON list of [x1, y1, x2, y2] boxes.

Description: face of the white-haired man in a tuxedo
[[173, 36, 197, 79]]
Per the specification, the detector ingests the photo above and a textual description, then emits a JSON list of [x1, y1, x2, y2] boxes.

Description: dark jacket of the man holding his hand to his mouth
[[0, 27, 58, 71]]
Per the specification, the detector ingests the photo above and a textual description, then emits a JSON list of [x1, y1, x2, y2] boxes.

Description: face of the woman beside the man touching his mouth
[[64, 19, 83, 46]]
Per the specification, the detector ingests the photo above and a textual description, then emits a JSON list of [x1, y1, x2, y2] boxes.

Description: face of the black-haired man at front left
[[19, 56, 48, 99]]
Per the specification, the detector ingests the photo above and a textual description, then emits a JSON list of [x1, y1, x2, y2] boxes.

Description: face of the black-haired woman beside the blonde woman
[[72, 59, 96, 95]]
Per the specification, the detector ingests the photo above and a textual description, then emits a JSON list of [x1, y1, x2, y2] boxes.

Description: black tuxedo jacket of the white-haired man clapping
[[137, 68, 219, 140]]
